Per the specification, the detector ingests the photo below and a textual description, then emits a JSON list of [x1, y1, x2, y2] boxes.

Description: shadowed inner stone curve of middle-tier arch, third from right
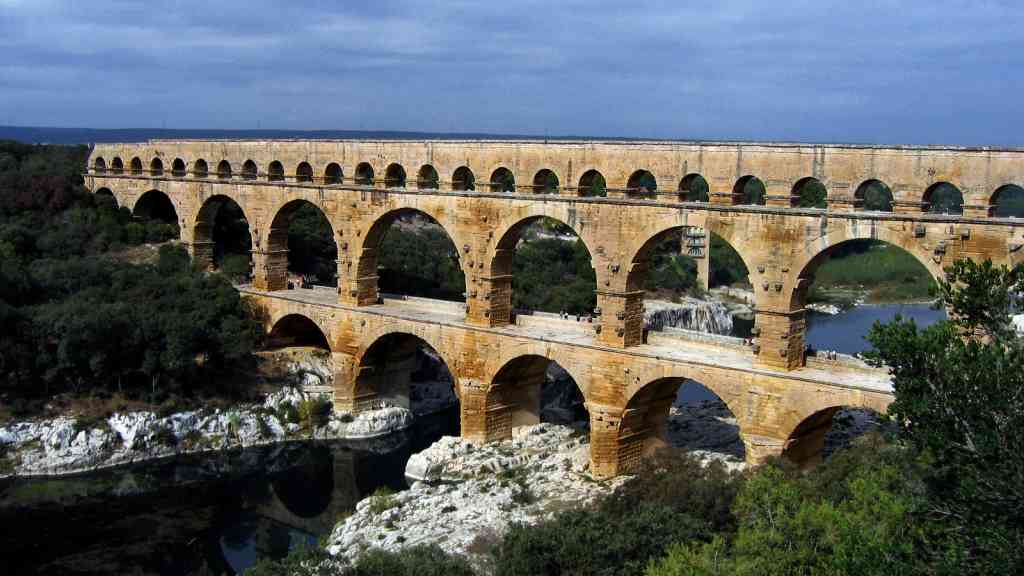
[[488, 214, 597, 317]]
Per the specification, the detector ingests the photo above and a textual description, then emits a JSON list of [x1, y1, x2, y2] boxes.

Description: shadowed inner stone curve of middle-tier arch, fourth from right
[[355, 208, 466, 303]]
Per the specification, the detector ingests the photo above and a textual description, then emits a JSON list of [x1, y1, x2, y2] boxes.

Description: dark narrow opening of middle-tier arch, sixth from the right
[[191, 194, 253, 282]]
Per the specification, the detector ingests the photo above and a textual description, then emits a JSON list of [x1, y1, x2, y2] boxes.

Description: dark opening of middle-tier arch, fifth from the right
[[267, 199, 338, 287]]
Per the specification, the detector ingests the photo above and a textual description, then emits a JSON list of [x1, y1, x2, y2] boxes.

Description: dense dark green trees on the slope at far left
[[0, 142, 260, 415]]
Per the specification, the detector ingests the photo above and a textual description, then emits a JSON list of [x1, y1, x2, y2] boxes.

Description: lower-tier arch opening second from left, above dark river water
[[352, 332, 459, 416]]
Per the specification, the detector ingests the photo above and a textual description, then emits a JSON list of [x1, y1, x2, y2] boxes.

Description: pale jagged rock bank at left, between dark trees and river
[[0, 387, 413, 478]]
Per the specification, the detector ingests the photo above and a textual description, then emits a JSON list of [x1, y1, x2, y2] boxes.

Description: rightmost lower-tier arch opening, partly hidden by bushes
[[782, 405, 885, 467]]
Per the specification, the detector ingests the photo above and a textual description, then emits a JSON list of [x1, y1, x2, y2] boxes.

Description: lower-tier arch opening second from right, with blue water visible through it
[[618, 376, 746, 461]]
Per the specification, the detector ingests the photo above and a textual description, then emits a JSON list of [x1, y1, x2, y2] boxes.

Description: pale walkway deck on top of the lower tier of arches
[[239, 285, 893, 394]]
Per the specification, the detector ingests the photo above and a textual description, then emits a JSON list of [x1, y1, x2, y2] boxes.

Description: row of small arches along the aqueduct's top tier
[[89, 148, 1024, 218]]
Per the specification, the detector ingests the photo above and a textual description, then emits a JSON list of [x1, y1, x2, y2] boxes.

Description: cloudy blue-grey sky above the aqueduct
[[0, 0, 1024, 146]]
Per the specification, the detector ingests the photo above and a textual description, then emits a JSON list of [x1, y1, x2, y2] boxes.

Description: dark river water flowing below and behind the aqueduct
[[0, 304, 945, 575]]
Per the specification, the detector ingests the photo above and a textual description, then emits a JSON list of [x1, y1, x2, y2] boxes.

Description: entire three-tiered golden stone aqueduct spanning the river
[[85, 140, 1024, 476]]
